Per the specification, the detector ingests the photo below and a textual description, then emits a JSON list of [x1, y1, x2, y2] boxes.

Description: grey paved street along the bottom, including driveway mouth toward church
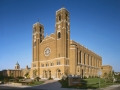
[[0, 80, 120, 90]]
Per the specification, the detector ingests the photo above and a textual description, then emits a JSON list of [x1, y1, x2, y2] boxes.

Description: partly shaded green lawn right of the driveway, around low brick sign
[[59, 78, 120, 89]]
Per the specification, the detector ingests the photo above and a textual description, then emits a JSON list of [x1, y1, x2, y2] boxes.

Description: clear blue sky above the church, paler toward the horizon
[[0, 0, 120, 71]]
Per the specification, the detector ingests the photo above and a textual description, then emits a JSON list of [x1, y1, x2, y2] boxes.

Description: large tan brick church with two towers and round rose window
[[31, 7, 102, 79]]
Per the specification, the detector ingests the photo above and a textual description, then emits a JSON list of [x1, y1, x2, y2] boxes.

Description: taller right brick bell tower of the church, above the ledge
[[55, 8, 70, 58]]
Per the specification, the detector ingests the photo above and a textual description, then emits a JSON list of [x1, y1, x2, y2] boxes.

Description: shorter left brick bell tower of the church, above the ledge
[[32, 22, 44, 62]]
